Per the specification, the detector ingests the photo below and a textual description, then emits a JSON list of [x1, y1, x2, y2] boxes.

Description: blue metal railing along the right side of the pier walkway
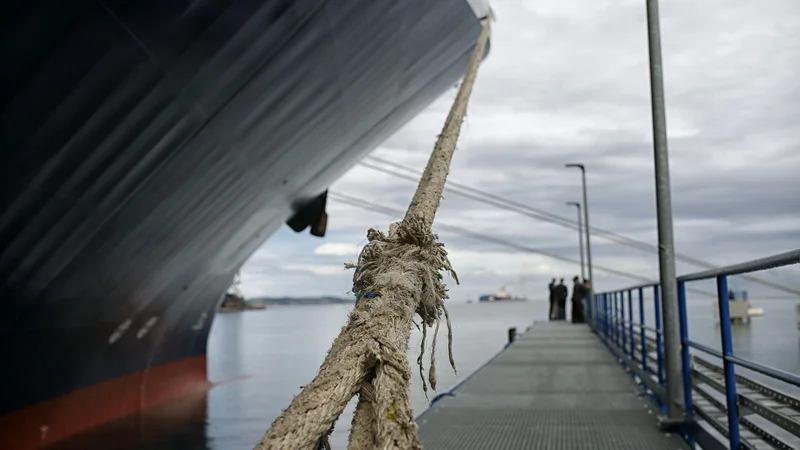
[[587, 250, 800, 449]]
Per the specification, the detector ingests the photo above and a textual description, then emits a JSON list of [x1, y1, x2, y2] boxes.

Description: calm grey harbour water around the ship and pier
[[42, 300, 800, 450]]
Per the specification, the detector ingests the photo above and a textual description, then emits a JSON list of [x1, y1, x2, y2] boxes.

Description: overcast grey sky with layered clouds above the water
[[236, 0, 800, 301]]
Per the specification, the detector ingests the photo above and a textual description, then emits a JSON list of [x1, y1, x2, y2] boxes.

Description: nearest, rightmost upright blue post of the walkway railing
[[717, 276, 742, 450]]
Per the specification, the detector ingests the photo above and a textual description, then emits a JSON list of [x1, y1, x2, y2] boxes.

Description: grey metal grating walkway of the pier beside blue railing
[[418, 322, 689, 450]]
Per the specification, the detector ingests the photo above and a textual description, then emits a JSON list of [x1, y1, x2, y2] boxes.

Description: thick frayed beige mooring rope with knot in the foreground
[[255, 14, 490, 450]]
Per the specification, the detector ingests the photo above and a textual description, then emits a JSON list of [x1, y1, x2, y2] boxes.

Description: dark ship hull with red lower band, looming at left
[[0, 0, 488, 448]]
